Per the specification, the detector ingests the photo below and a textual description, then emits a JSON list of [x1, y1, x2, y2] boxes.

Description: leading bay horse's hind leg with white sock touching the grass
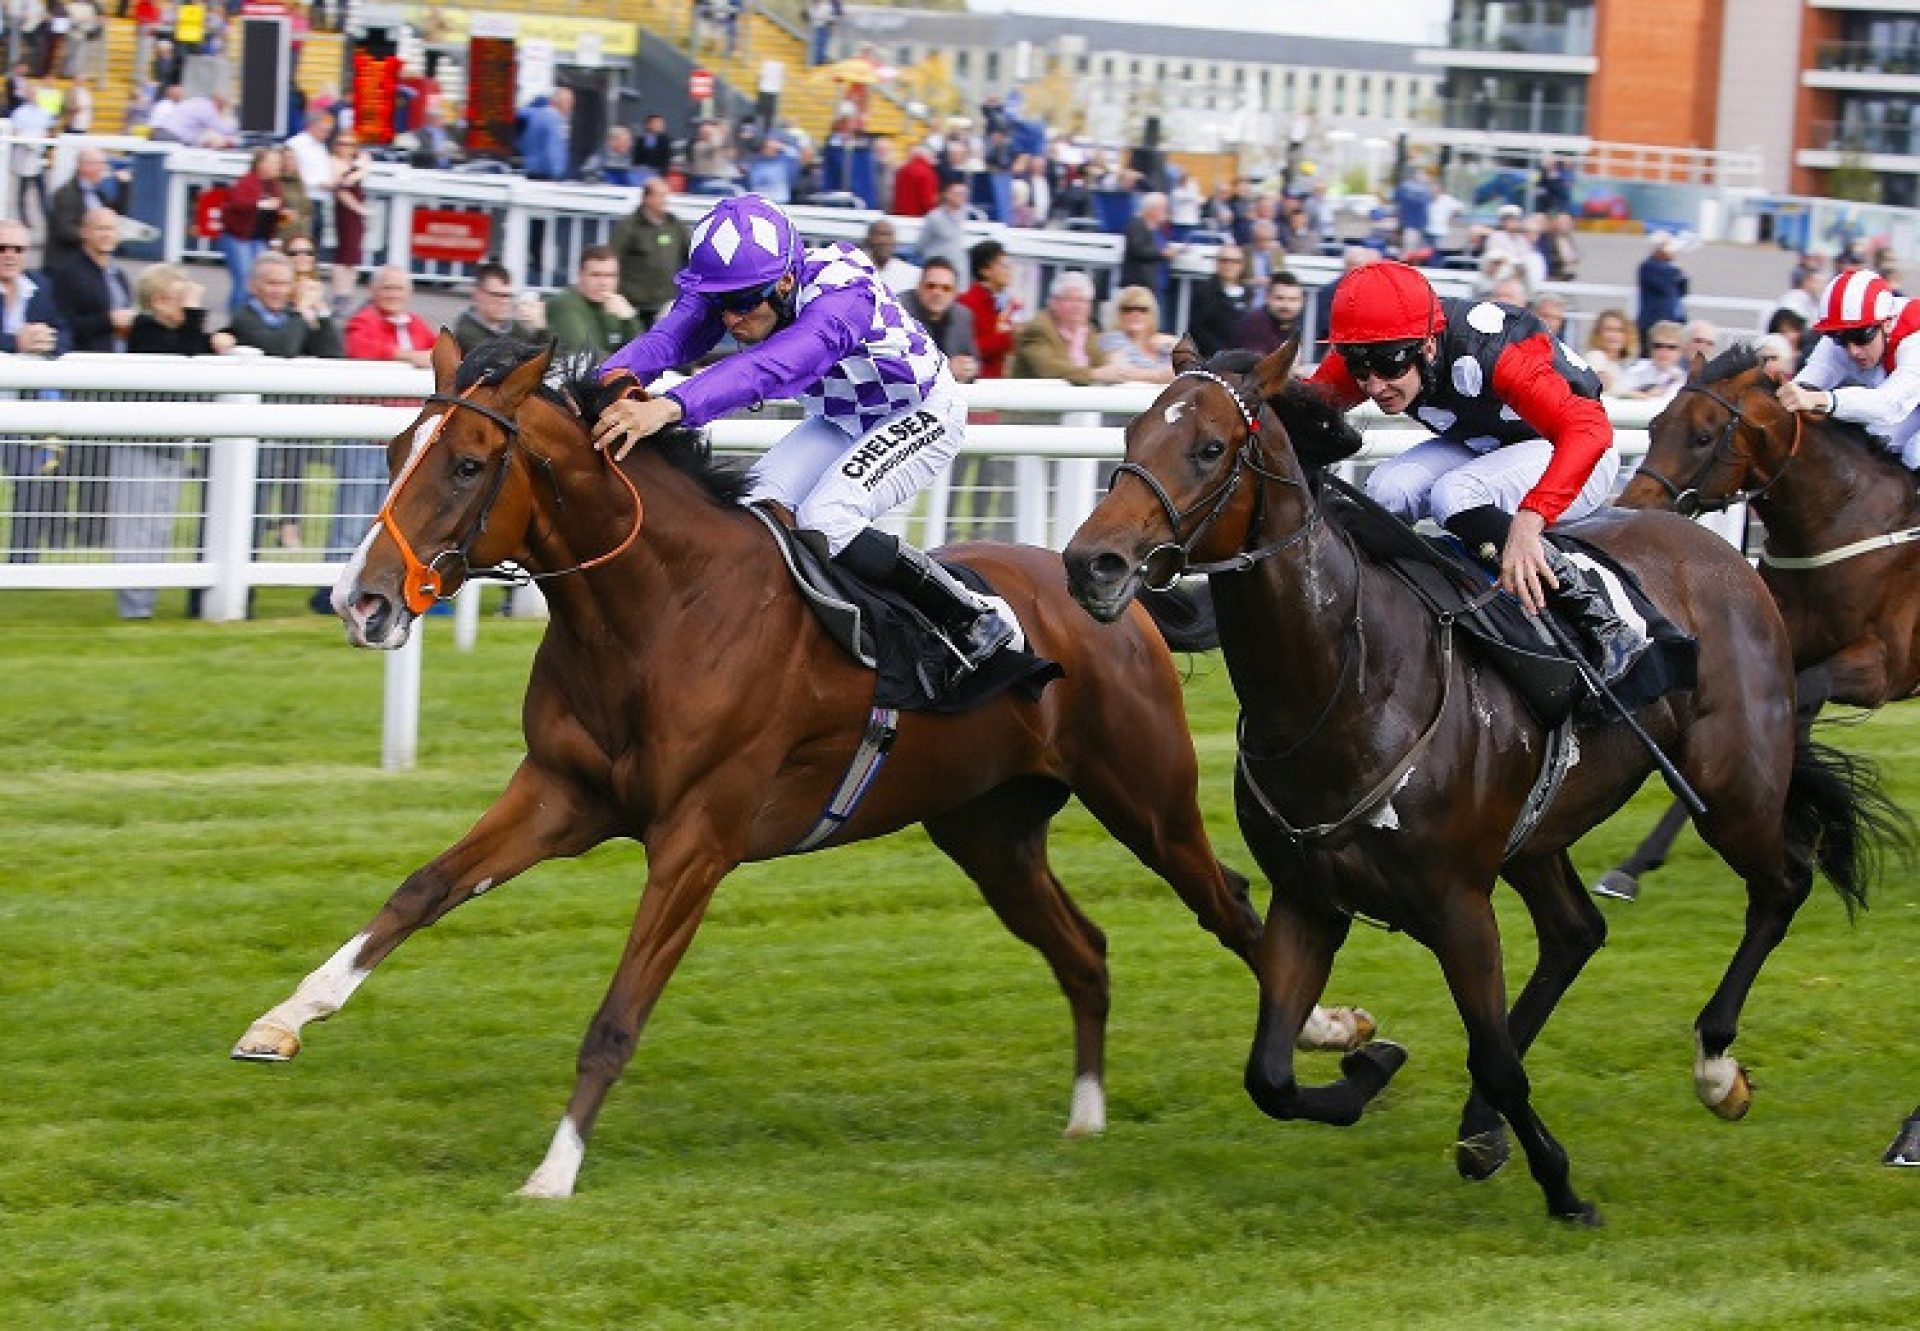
[[925, 780, 1110, 1137]]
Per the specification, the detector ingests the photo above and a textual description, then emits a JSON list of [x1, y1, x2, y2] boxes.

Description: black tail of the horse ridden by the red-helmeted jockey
[[1786, 732, 1914, 918]]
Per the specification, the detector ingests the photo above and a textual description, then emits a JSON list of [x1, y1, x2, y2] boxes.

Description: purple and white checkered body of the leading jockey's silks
[[795, 244, 947, 438]]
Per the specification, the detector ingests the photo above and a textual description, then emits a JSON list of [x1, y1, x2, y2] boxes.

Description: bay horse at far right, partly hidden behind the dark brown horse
[[1601, 348, 1920, 897]]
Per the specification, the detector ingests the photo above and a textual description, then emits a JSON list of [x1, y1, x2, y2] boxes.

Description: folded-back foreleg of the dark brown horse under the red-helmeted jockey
[[1246, 891, 1407, 1127]]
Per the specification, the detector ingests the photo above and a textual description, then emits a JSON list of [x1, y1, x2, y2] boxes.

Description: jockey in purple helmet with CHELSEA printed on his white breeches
[[593, 194, 1014, 674]]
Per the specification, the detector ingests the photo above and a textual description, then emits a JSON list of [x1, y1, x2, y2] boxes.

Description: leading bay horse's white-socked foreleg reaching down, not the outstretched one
[[520, 820, 745, 1198]]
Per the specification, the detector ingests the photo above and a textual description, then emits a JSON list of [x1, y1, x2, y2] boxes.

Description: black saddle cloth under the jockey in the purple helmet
[[747, 503, 1066, 713]]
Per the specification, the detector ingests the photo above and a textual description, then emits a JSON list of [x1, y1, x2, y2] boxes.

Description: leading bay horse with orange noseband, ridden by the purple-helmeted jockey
[[234, 332, 1371, 1197]]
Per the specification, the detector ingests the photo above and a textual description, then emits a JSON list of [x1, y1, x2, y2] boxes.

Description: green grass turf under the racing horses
[[0, 592, 1920, 1329]]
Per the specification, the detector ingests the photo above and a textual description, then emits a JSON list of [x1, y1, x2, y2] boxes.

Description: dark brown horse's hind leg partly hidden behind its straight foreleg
[[1453, 851, 1607, 1181]]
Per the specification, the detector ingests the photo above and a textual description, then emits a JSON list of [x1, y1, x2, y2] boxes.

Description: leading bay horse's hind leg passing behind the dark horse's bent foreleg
[[1073, 749, 1379, 1051]]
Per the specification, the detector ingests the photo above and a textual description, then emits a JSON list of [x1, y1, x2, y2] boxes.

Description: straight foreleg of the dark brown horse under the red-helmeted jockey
[[1432, 891, 1599, 1225]]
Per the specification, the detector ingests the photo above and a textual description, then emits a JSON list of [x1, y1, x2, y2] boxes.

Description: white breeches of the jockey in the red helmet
[[1367, 430, 1620, 526]]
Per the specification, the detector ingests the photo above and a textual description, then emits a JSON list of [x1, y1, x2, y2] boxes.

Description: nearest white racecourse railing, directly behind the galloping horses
[[0, 355, 1740, 766]]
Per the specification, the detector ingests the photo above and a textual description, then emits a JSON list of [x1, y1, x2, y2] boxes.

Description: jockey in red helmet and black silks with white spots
[[1311, 261, 1647, 682]]
